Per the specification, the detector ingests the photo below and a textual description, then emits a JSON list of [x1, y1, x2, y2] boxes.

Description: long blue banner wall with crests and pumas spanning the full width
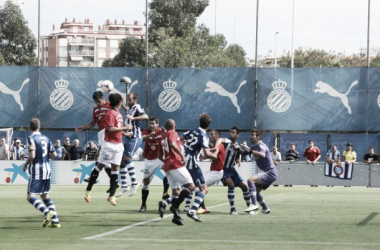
[[0, 66, 380, 132]]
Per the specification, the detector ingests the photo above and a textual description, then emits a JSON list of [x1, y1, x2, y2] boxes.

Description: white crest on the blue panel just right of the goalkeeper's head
[[267, 80, 292, 113]]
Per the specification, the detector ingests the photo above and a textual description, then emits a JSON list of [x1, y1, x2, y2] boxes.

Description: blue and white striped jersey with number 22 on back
[[182, 128, 209, 169]]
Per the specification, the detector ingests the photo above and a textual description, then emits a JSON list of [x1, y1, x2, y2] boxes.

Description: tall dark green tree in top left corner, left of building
[[0, 0, 37, 65]]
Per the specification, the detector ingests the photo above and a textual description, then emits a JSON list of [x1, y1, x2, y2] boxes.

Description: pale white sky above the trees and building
[[0, 0, 380, 59]]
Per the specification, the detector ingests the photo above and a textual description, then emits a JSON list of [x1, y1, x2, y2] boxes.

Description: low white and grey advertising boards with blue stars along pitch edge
[[0, 161, 380, 187]]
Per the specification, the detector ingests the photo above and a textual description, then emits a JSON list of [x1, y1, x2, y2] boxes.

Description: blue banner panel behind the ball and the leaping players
[[40, 67, 145, 128]]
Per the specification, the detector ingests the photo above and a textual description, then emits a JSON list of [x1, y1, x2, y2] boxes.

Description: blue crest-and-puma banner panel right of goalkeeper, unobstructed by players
[[257, 68, 368, 131]]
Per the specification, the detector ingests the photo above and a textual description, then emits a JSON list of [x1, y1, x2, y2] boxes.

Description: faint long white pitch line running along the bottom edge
[[95, 238, 380, 246]]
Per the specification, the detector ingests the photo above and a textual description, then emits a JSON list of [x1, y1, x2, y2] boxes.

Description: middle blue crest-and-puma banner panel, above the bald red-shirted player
[[149, 68, 254, 129]]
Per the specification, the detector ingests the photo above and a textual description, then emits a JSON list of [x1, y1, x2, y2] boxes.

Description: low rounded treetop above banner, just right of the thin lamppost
[[279, 49, 341, 68]]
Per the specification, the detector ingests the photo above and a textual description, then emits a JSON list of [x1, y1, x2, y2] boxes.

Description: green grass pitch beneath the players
[[0, 186, 380, 250]]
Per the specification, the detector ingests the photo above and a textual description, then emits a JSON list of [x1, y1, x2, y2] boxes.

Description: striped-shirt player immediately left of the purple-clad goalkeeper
[[216, 127, 251, 215]]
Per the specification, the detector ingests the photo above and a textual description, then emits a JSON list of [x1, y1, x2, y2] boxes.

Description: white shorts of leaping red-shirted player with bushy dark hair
[[98, 141, 124, 166]]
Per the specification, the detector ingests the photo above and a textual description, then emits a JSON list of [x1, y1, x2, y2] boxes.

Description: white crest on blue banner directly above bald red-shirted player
[[158, 78, 182, 112]]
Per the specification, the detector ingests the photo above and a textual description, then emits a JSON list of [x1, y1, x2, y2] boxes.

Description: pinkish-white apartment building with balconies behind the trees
[[40, 18, 145, 67]]
